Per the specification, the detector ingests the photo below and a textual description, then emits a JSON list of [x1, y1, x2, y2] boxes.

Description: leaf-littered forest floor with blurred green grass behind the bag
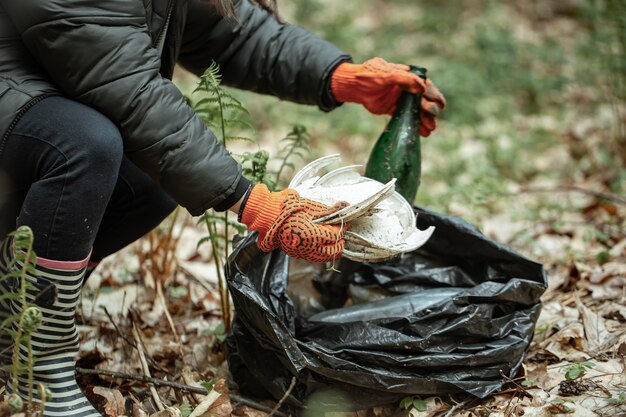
[[0, 0, 626, 417]]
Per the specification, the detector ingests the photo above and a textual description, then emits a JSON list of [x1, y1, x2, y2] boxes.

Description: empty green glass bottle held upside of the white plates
[[365, 65, 426, 204]]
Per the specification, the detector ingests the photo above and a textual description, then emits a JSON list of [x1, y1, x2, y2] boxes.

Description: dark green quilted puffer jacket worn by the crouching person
[[0, 0, 349, 215]]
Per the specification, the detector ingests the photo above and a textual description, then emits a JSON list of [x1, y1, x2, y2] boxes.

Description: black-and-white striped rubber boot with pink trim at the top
[[7, 247, 101, 417]]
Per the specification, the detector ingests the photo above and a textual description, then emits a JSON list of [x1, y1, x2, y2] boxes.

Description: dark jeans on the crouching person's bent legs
[[0, 97, 176, 261]]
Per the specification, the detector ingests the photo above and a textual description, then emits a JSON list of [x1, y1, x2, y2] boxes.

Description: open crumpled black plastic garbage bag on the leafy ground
[[227, 208, 547, 409]]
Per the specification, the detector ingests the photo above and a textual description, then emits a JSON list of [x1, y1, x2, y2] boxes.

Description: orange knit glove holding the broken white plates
[[240, 184, 348, 263]]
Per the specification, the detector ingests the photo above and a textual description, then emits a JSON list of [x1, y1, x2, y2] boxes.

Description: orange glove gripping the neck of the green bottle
[[330, 58, 446, 137]]
